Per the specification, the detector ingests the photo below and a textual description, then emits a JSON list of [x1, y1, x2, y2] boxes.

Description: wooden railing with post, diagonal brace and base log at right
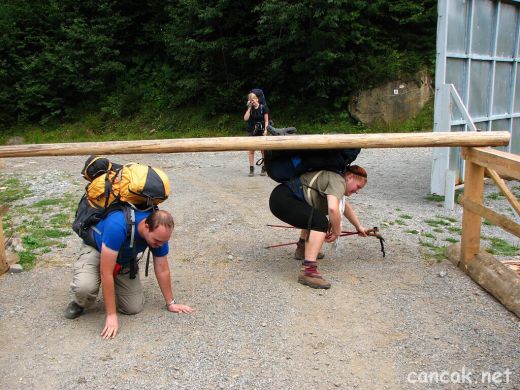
[[456, 148, 520, 317]]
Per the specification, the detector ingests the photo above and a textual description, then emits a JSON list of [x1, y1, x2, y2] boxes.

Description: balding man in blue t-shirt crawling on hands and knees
[[65, 210, 191, 339]]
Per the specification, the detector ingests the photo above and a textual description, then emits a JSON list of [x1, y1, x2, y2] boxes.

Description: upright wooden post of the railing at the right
[[460, 160, 484, 268]]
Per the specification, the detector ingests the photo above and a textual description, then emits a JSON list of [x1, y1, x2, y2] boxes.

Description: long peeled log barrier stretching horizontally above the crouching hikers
[[0, 131, 511, 158]]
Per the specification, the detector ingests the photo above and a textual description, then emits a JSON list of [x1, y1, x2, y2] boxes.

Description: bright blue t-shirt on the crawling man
[[94, 210, 169, 265]]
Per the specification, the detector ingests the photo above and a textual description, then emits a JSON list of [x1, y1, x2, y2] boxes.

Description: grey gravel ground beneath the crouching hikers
[[0, 148, 520, 389]]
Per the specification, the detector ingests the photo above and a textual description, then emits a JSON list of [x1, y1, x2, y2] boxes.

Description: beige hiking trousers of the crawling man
[[70, 244, 144, 314]]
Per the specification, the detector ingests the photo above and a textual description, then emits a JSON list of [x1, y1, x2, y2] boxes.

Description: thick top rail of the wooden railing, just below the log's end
[[462, 148, 520, 179]]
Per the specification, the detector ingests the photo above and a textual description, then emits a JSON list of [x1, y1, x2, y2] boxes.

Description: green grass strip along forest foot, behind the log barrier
[[0, 105, 380, 144]]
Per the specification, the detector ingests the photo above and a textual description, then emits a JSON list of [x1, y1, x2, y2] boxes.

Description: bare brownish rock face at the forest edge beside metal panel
[[348, 70, 433, 126]]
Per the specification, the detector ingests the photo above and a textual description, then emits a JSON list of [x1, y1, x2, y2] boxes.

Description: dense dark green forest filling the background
[[0, 0, 437, 126]]
